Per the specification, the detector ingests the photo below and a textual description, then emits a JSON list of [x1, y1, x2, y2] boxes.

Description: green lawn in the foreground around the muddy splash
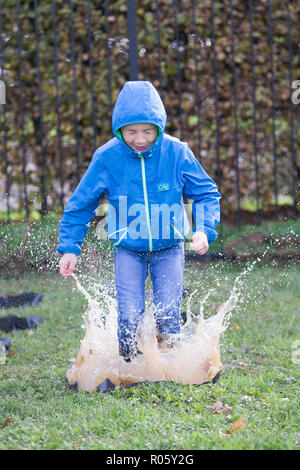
[[0, 262, 300, 450]]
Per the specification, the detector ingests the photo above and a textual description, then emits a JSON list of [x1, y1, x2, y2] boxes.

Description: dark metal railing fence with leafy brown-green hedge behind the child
[[0, 0, 300, 228]]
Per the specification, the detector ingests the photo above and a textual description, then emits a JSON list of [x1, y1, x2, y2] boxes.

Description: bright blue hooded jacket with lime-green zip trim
[[57, 81, 221, 255]]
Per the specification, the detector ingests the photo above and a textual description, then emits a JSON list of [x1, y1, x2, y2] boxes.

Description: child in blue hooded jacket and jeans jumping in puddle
[[57, 81, 221, 361]]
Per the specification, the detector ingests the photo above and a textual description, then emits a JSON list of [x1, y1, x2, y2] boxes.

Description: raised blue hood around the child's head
[[112, 81, 167, 138]]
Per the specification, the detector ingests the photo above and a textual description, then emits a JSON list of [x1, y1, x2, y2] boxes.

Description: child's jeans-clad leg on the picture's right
[[150, 242, 184, 345]]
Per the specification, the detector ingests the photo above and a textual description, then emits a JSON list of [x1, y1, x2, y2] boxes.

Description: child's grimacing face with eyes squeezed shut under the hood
[[122, 124, 157, 152]]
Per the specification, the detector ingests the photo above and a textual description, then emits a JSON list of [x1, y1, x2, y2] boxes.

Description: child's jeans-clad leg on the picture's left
[[114, 247, 148, 360]]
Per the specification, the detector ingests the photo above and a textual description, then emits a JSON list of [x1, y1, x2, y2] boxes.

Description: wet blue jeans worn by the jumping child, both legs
[[114, 241, 184, 359]]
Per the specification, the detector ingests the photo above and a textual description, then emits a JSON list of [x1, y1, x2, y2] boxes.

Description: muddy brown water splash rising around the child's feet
[[66, 262, 255, 391]]
